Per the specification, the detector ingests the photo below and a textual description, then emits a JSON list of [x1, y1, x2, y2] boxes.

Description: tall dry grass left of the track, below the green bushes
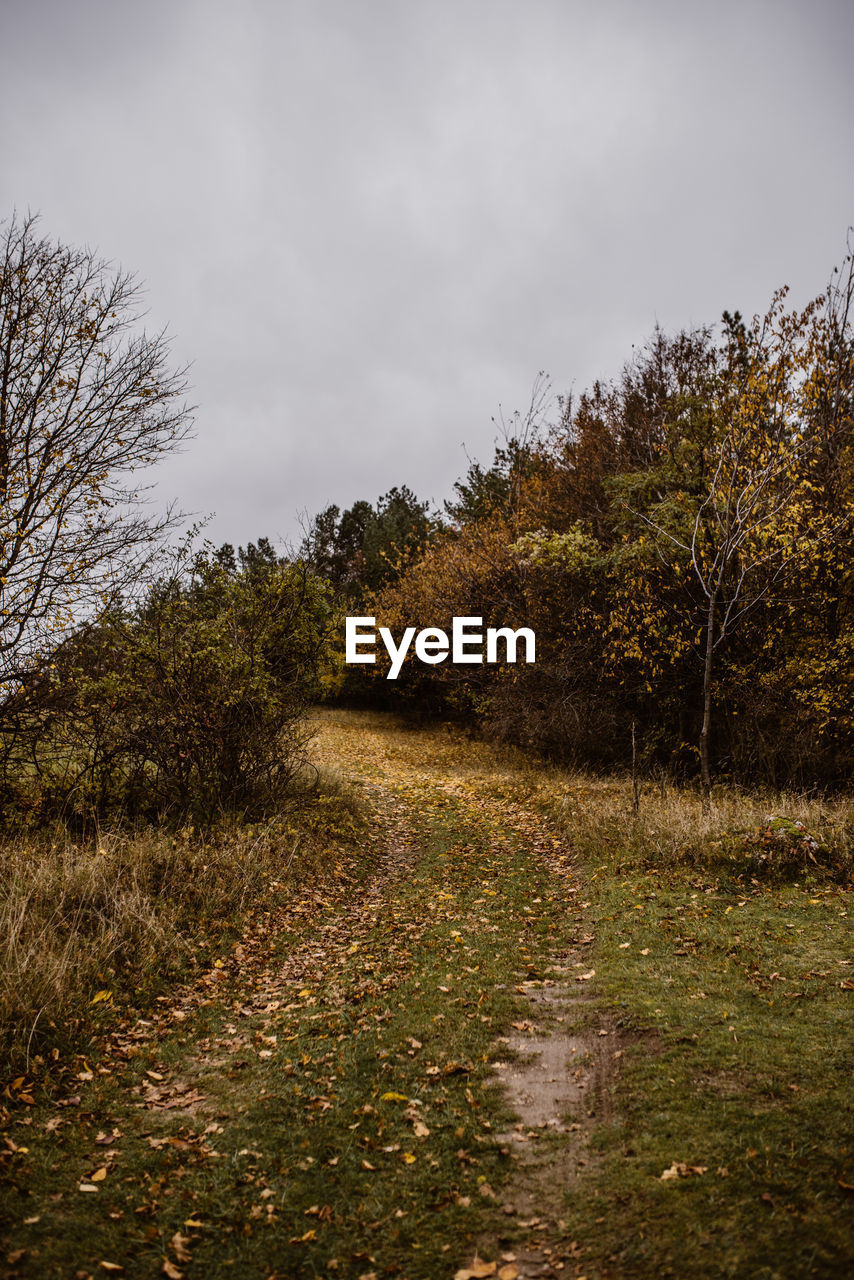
[[0, 780, 362, 1070]]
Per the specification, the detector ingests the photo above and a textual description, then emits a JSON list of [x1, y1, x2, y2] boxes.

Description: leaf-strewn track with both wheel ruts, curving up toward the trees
[[3, 714, 620, 1280]]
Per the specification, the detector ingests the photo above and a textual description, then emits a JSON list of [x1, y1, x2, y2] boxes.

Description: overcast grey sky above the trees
[[0, 0, 854, 543]]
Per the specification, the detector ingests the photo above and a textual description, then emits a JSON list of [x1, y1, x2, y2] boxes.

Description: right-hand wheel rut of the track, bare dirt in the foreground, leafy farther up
[[307, 716, 622, 1280]]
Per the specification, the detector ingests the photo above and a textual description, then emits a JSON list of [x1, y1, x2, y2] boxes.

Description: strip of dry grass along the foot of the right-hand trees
[[314, 708, 854, 883]]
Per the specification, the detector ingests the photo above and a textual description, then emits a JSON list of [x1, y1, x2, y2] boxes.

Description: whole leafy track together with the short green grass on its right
[[0, 714, 854, 1280]]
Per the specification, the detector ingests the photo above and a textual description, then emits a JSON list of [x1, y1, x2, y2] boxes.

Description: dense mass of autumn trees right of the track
[[361, 255, 854, 796]]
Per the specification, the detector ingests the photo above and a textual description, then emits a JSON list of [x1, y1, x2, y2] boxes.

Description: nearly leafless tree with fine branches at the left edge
[[0, 215, 191, 698]]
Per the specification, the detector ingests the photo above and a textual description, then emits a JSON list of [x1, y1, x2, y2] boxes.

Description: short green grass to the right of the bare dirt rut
[[560, 868, 854, 1280]]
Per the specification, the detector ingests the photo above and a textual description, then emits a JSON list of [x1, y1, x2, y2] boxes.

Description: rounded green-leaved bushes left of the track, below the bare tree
[[6, 556, 329, 823]]
